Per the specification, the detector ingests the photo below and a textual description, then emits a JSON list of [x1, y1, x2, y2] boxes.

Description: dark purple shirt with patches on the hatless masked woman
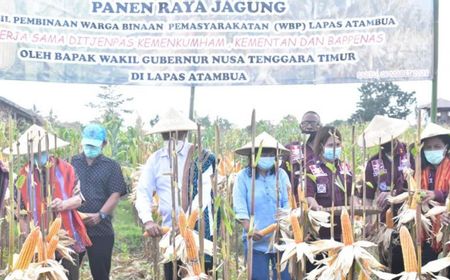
[[306, 161, 352, 240]]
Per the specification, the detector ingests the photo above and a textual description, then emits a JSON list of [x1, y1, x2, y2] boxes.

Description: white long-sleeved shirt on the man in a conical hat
[[135, 142, 213, 227]]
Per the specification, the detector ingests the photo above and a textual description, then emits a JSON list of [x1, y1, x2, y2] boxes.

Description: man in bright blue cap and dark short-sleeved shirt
[[72, 123, 127, 280]]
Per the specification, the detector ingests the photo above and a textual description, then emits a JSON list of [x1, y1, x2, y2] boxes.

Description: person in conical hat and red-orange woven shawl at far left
[[5, 125, 92, 280]]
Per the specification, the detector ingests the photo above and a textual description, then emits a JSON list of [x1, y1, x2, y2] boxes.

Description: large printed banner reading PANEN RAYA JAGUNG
[[0, 0, 433, 85]]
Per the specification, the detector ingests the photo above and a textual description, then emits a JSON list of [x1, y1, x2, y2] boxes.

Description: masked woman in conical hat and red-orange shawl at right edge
[[420, 123, 450, 264]]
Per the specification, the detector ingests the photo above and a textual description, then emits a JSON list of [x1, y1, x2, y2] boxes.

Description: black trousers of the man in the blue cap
[[80, 235, 114, 280]]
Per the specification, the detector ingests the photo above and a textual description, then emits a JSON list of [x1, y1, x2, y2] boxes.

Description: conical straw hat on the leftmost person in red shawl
[[3, 124, 69, 155]]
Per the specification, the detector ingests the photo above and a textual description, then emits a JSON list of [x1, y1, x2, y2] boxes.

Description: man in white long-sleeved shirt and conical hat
[[135, 109, 216, 280]]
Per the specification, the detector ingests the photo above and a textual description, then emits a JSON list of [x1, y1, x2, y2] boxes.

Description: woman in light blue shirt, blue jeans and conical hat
[[233, 132, 290, 280]]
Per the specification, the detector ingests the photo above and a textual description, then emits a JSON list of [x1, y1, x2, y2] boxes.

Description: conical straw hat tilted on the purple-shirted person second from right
[[358, 115, 409, 148]]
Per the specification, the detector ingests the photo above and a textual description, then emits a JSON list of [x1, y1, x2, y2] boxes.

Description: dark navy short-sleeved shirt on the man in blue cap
[[72, 154, 127, 236]]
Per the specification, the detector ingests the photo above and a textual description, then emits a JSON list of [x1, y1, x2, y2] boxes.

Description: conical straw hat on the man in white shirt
[[148, 108, 197, 134]]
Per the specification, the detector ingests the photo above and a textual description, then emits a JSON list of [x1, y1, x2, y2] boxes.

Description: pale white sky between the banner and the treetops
[[0, 1, 450, 127]]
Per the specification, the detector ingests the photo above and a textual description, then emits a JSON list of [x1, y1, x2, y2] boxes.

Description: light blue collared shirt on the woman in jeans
[[233, 167, 291, 252]]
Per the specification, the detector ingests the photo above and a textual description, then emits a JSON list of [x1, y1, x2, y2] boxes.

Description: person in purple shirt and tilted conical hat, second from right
[[358, 115, 415, 273]]
